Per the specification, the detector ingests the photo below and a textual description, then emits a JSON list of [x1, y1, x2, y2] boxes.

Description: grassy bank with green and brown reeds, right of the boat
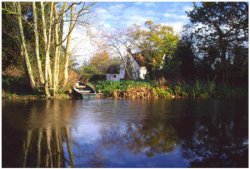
[[96, 81, 248, 99]]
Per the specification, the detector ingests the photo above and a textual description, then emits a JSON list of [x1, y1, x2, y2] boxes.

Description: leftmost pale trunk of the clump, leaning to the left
[[16, 2, 36, 89]]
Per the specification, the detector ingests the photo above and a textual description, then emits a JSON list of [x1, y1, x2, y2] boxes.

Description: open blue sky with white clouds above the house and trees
[[92, 2, 193, 32]]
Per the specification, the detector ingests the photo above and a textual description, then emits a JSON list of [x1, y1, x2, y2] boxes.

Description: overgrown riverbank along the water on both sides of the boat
[[2, 78, 248, 101]]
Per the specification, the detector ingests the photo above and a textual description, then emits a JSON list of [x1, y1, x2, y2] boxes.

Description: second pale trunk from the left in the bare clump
[[32, 2, 44, 84]]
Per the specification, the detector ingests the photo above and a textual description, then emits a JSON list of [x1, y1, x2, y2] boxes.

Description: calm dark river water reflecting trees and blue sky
[[2, 99, 248, 168]]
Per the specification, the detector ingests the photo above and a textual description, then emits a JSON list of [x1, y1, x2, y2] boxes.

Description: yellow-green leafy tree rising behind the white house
[[130, 21, 179, 78]]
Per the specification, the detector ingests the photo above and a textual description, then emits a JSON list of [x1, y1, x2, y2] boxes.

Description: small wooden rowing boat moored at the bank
[[73, 81, 97, 99]]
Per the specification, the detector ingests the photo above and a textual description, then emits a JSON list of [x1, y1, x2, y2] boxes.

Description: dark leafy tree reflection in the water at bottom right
[[181, 113, 248, 167]]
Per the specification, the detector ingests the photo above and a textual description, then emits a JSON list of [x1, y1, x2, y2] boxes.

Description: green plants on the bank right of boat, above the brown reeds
[[96, 80, 247, 98]]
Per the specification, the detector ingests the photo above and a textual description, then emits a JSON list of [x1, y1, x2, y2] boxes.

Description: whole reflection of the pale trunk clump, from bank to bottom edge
[[3, 101, 75, 167]]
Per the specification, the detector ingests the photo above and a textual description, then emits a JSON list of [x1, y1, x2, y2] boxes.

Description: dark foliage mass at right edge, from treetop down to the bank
[[187, 2, 249, 85]]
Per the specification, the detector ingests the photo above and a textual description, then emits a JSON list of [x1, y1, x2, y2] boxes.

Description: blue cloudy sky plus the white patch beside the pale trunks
[[72, 2, 193, 65]]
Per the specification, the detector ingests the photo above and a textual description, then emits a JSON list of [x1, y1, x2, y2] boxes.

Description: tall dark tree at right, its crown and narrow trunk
[[187, 2, 248, 83]]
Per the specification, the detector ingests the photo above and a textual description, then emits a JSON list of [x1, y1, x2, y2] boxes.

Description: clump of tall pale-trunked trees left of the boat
[[3, 2, 94, 97]]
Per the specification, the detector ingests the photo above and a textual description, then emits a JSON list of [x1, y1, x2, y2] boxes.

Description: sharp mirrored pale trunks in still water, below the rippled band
[[22, 127, 74, 167]]
